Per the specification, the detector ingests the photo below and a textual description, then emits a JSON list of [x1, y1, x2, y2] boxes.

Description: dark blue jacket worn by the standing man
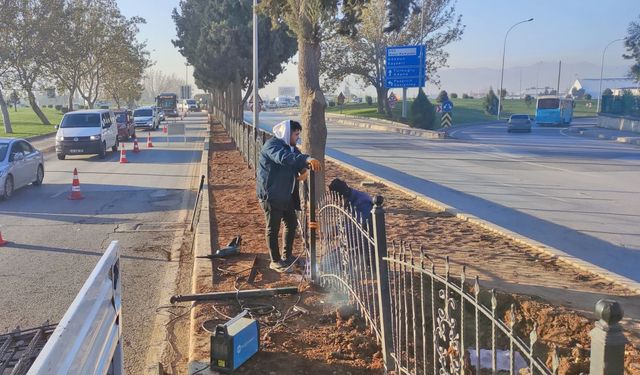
[[256, 137, 309, 210]]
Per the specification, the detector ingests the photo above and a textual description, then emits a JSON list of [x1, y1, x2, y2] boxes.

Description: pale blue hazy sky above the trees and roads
[[118, 0, 640, 98]]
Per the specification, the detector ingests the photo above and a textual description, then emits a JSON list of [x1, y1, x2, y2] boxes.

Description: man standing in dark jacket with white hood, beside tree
[[256, 120, 321, 272]]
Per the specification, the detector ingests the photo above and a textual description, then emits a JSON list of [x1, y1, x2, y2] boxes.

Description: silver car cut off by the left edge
[[0, 138, 44, 199]]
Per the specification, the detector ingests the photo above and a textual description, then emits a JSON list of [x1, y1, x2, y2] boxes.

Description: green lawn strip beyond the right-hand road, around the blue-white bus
[[327, 99, 596, 125]]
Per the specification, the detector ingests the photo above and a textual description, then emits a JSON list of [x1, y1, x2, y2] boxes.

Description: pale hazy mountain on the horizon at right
[[427, 62, 629, 96]]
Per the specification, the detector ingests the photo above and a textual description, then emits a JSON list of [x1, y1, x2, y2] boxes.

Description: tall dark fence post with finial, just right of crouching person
[[371, 195, 395, 372]]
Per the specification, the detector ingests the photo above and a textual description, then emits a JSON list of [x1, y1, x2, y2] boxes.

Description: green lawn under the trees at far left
[[0, 108, 62, 138]]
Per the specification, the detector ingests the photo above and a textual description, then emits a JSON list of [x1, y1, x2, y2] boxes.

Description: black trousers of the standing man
[[260, 201, 298, 262]]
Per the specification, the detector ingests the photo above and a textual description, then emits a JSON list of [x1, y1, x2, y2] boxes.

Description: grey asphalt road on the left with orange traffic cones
[[0, 114, 207, 373]]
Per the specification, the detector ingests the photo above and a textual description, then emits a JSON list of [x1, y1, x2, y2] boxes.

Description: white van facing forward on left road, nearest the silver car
[[56, 109, 118, 160]]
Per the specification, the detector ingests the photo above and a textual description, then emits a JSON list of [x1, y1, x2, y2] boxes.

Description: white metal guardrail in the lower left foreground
[[28, 241, 124, 375]]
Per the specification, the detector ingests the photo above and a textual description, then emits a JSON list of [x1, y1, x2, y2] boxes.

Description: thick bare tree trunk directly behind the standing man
[[298, 36, 327, 198]]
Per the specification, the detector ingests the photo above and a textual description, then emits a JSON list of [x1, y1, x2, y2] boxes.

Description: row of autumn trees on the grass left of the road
[[0, 0, 151, 133]]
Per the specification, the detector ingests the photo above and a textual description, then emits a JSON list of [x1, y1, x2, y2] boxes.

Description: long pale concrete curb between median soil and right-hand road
[[326, 156, 640, 294]]
